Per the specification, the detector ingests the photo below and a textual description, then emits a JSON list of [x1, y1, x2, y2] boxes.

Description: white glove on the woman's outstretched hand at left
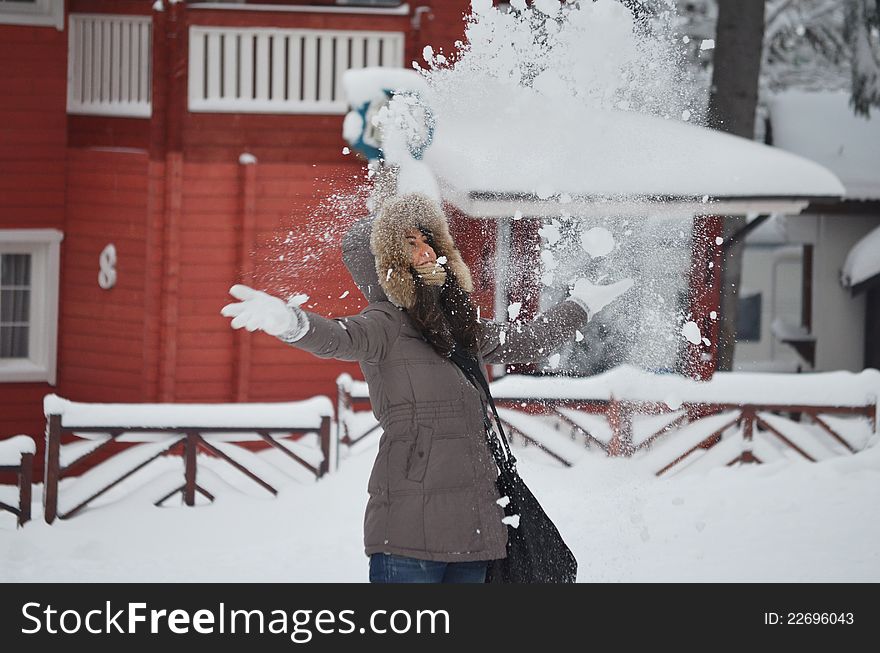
[[220, 284, 309, 342]]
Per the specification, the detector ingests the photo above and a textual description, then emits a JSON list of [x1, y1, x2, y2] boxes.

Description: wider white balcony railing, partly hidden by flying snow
[[189, 26, 404, 114]]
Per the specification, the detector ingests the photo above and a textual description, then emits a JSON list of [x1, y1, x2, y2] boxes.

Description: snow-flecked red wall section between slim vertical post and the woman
[[250, 160, 366, 401]]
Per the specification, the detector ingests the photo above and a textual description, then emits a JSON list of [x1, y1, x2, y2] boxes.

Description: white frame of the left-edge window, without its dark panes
[[0, 229, 64, 385]]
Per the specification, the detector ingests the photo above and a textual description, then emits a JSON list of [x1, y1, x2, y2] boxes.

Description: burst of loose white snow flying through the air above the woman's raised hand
[[422, 0, 703, 374]]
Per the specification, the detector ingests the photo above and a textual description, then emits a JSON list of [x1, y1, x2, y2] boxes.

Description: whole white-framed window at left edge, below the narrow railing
[[0, 229, 62, 385]]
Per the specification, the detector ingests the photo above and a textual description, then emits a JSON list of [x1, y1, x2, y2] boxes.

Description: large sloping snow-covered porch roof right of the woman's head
[[424, 84, 844, 216]]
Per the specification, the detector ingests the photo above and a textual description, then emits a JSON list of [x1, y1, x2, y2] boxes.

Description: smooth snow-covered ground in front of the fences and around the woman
[[0, 428, 880, 582]]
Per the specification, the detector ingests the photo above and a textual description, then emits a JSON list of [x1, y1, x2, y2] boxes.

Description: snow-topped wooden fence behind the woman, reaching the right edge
[[337, 370, 880, 476]]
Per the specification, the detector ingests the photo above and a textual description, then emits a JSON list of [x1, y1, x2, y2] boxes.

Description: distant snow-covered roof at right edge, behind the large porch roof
[[769, 91, 880, 200]]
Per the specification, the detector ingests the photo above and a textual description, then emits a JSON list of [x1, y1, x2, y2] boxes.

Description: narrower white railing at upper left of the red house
[[67, 14, 152, 117]]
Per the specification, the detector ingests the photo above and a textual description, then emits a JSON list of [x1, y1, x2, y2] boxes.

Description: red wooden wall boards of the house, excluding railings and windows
[[0, 0, 474, 473]]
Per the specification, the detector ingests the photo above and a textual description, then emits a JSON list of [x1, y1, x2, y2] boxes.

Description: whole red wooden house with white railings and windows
[[0, 0, 844, 473]]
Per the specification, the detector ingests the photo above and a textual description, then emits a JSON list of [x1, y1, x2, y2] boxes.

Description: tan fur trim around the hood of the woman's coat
[[370, 193, 474, 309]]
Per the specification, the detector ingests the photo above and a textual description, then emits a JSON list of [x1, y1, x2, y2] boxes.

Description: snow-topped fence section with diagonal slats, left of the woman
[[37, 395, 335, 524]]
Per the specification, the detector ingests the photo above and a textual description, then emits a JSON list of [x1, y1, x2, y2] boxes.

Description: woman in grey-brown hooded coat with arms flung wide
[[221, 194, 632, 582]]
